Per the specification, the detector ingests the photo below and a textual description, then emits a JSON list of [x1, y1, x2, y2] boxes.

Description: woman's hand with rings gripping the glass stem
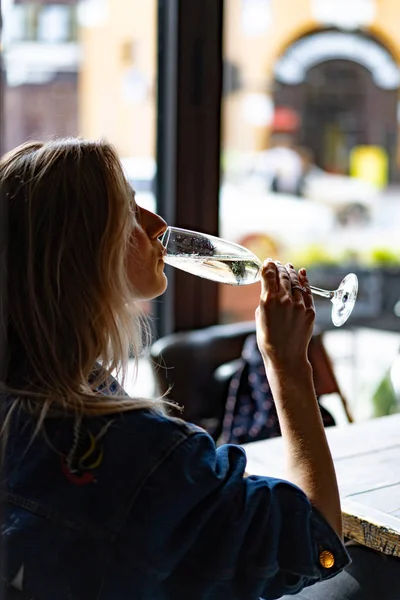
[[256, 259, 315, 371]]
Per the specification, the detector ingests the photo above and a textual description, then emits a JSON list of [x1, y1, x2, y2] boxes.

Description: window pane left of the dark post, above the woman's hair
[[1, 0, 157, 322]]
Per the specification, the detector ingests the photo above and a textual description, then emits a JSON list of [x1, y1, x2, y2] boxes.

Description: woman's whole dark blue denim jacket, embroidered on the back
[[1, 390, 349, 600]]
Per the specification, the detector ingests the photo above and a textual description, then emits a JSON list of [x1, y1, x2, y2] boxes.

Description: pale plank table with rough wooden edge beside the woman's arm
[[244, 414, 400, 557]]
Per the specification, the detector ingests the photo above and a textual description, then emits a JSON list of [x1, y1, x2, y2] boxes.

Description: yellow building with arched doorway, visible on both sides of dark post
[[76, 0, 400, 178]]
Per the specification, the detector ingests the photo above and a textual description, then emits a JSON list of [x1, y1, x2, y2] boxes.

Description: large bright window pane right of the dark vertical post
[[220, 0, 400, 324]]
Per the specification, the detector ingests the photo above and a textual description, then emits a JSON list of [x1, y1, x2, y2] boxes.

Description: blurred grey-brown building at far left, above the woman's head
[[2, 0, 80, 150]]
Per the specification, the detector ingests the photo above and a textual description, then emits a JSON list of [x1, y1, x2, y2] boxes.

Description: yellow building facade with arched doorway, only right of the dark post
[[224, 0, 400, 179]]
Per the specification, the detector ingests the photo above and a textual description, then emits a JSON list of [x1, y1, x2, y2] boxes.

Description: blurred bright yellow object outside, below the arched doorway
[[350, 146, 389, 189]]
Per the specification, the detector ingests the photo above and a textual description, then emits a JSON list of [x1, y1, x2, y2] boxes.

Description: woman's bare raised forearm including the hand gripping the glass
[[256, 261, 342, 537]]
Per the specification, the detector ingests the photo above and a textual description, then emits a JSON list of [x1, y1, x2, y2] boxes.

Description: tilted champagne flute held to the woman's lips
[[160, 227, 358, 327]]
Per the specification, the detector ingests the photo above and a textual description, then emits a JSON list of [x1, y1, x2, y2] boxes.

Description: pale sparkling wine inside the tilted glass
[[164, 255, 261, 285]]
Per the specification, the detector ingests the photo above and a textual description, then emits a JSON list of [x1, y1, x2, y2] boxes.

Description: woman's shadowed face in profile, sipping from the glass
[[127, 200, 168, 300]]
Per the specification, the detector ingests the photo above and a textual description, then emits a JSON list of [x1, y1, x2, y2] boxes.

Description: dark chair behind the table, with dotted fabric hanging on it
[[150, 321, 353, 440]]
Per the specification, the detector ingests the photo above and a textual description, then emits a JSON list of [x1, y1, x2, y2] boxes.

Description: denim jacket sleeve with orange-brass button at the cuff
[[123, 432, 349, 600]]
